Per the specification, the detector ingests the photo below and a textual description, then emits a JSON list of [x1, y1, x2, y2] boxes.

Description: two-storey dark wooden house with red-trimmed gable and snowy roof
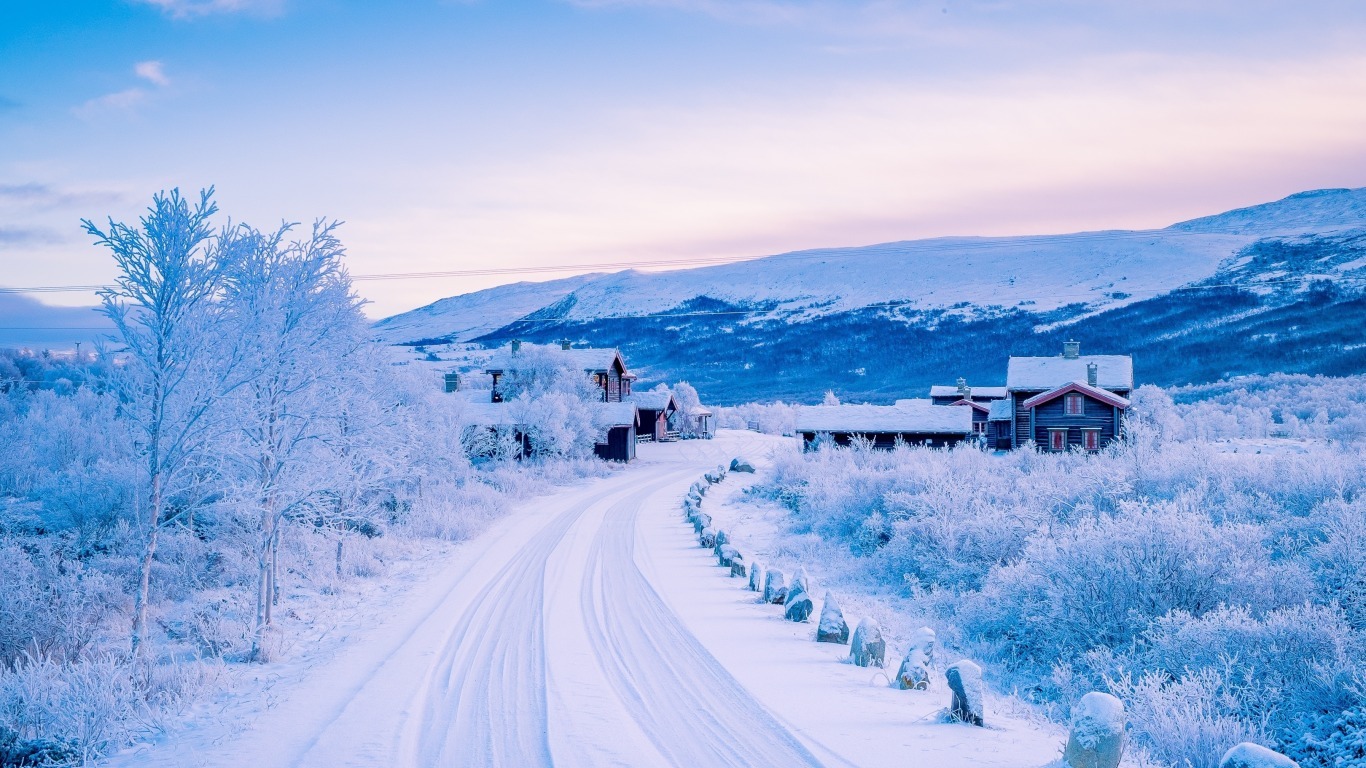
[[1005, 342, 1134, 451]]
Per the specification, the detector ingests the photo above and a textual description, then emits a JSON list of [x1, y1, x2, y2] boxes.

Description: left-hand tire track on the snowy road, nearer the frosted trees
[[403, 478, 632, 767]]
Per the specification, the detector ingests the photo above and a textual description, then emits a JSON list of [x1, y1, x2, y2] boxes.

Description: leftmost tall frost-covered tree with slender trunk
[[82, 189, 239, 653]]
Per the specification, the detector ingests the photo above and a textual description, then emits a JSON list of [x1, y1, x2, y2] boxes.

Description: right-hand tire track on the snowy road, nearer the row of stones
[[581, 482, 821, 767]]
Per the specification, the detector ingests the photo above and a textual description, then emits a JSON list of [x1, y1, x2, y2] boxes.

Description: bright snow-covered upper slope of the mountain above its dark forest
[[376, 189, 1366, 343]]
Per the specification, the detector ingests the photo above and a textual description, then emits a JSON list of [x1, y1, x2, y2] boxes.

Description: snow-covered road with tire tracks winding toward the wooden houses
[[112, 432, 1056, 767]]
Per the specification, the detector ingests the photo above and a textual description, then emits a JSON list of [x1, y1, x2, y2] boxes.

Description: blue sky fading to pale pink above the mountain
[[0, 0, 1366, 316]]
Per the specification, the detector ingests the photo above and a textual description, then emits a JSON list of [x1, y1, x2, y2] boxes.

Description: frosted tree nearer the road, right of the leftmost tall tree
[[223, 221, 366, 657]]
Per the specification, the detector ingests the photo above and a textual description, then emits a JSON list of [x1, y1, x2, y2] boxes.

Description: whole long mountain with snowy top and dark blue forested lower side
[[376, 189, 1366, 403]]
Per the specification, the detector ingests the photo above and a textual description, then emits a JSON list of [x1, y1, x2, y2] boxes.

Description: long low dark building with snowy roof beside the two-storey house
[[796, 400, 973, 450]]
